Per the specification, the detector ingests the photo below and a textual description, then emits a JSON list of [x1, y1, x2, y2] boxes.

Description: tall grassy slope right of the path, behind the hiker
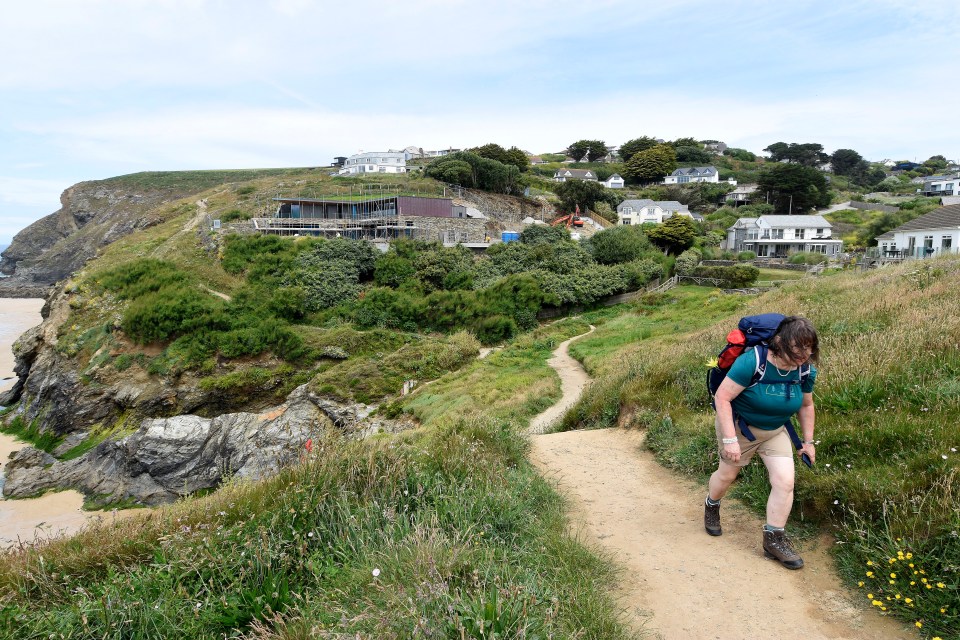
[[568, 259, 960, 638]]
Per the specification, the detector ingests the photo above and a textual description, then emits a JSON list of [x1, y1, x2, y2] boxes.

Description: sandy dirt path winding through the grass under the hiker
[[531, 330, 917, 640]]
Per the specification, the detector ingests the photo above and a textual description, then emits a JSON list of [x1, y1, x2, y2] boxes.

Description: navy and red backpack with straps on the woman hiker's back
[[707, 313, 810, 449]]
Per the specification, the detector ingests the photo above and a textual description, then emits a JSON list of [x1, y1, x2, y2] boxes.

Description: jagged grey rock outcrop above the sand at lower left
[[3, 385, 400, 505]]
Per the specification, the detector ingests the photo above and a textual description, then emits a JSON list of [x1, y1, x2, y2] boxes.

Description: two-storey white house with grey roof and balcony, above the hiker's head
[[724, 216, 843, 257]]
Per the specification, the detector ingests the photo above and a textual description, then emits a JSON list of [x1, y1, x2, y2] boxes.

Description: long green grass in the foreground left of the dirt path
[[0, 364, 634, 640]]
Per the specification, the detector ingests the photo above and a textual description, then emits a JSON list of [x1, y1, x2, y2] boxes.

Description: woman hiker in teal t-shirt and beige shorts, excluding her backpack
[[703, 316, 819, 569]]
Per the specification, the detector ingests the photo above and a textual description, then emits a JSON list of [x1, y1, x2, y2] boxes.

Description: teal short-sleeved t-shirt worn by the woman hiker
[[727, 349, 817, 430]]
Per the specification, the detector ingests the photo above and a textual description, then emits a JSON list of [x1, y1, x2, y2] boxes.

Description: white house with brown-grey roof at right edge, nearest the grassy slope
[[877, 204, 960, 258]]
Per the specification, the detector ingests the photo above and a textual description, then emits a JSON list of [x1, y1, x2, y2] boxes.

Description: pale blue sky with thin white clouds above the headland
[[0, 0, 960, 245]]
